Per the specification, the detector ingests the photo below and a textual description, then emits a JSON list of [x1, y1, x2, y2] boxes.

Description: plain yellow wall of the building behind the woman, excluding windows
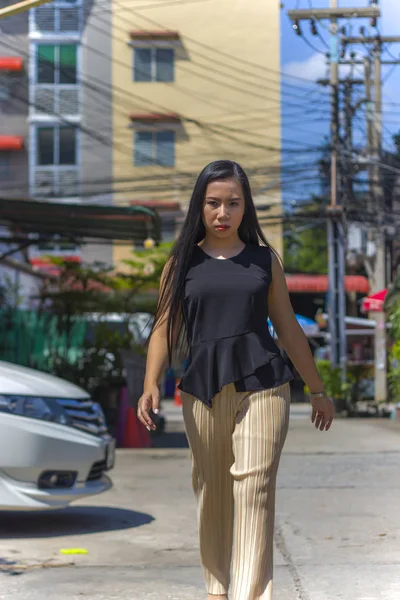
[[112, 0, 282, 264]]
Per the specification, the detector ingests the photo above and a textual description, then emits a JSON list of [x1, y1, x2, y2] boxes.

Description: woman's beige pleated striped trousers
[[181, 383, 290, 600]]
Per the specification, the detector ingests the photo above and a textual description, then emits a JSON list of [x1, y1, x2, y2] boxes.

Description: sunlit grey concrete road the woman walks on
[[0, 405, 400, 600]]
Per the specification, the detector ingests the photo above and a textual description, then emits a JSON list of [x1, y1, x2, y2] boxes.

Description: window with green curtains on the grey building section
[[36, 44, 78, 85]]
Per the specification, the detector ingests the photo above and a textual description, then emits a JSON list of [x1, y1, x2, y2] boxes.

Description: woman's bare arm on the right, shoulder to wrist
[[268, 254, 324, 392]]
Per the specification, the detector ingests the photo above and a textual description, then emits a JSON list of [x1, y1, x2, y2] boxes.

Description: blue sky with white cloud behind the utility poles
[[281, 0, 400, 203]]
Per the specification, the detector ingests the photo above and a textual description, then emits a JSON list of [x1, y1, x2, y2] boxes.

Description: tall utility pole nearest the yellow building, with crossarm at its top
[[288, 0, 380, 380]]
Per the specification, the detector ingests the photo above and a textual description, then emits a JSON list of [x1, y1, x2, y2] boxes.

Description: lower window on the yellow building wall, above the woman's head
[[134, 131, 175, 167]]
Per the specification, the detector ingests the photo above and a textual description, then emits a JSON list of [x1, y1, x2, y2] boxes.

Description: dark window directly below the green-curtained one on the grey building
[[36, 126, 77, 166]]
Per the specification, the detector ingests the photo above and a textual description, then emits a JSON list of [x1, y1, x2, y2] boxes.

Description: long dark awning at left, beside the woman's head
[[0, 198, 161, 244]]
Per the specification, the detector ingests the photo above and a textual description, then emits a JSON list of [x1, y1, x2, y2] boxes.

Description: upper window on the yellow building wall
[[133, 48, 175, 82]]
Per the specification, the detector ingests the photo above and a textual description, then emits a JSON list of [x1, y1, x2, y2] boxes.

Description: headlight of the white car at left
[[0, 394, 71, 425]]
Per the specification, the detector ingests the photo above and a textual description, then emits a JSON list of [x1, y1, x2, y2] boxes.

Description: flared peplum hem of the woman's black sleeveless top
[[178, 331, 281, 408]]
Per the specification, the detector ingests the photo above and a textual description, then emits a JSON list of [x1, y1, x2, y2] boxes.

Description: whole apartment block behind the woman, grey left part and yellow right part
[[0, 0, 282, 276]]
